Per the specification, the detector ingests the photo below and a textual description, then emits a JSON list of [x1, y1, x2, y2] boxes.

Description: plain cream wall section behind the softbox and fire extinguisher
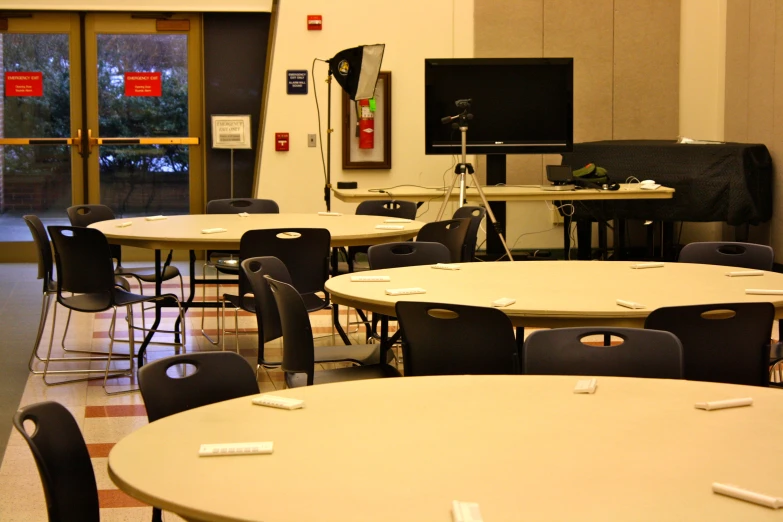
[[258, 0, 473, 221]]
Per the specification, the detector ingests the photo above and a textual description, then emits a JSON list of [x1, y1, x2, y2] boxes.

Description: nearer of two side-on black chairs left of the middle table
[[265, 276, 400, 388]]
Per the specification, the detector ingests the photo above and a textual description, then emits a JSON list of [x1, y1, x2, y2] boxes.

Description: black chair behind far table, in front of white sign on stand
[[201, 198, 280, 345]]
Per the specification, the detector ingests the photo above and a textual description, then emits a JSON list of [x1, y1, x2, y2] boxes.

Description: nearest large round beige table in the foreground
[[108, 375, 783, 522]]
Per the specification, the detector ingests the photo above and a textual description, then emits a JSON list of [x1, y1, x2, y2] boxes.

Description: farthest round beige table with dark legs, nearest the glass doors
[[90, 213, 424, 366]]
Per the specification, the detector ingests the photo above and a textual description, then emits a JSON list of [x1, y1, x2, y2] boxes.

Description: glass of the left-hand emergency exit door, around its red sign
[[0, 33, 71, 241]]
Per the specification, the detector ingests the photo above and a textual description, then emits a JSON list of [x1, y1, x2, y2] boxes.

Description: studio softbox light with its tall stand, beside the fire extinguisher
[[324, 44, 386, 211]]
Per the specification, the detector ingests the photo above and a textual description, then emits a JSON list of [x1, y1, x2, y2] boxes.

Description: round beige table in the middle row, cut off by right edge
[[326, 261, 783, 328]]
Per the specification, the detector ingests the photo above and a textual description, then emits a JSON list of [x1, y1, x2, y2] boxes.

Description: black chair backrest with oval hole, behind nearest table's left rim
[[139, 352, 258, 422]]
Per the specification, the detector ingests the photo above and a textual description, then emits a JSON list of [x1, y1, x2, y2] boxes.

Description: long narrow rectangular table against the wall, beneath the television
[[333, 183, 674, 259]]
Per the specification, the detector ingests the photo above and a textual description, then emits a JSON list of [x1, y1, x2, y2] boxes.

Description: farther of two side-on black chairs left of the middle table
[[241, 257, 380, 373]]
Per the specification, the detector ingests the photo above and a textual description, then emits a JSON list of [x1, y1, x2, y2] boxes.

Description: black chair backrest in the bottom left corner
[[14, 401, 100, 522]]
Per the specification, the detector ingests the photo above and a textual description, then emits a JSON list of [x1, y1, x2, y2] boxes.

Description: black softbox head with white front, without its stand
[[329, 44, 386, 101]]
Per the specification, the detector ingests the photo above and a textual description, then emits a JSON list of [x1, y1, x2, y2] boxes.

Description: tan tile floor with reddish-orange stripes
[[0, 265, 374, 522]]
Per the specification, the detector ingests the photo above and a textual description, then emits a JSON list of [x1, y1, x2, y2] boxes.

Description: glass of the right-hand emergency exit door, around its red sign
[[98, 34, 190, 217]]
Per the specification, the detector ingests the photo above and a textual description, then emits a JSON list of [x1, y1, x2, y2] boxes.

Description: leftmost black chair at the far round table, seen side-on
[[22, 215, 130, 375]]
